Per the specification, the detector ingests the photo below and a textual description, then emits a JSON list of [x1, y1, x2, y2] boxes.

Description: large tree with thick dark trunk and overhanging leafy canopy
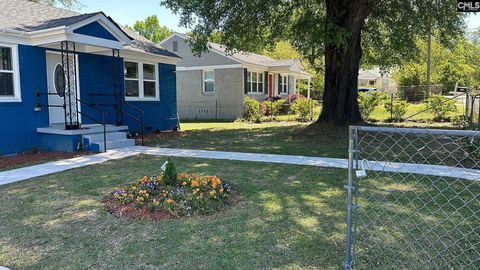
[[161, 0, 464, 124]]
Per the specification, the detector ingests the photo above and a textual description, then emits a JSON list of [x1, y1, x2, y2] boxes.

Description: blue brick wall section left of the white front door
[[0, 45, 48, 155]]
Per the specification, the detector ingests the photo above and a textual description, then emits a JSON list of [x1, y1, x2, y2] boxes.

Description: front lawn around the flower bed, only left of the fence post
[[0, 156, 346, 269]]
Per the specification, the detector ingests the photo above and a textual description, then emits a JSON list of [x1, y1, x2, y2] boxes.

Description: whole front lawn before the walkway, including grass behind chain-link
[[0, 156, 480, 270]]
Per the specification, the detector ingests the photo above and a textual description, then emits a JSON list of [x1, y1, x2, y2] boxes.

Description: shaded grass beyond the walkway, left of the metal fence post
[[146, 122, 348, 158]]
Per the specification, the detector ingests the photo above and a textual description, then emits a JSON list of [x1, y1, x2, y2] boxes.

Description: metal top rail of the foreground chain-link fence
[[350, 126, 480, 137]]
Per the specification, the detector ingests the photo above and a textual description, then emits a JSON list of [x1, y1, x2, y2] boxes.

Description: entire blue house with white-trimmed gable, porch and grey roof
[[0, 0, 180, 155]]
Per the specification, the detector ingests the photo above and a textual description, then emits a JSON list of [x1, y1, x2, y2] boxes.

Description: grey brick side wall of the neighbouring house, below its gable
[[177, 68, 243, 119]]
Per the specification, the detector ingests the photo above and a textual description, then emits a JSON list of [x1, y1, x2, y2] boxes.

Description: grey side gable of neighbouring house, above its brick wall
[[160, 35, 239, 67]]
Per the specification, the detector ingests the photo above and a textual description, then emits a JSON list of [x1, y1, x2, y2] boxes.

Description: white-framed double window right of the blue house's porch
[[124, 61, 159, 100]]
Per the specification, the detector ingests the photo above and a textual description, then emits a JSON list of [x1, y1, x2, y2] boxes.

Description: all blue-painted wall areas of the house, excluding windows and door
[[0, 45, 177, 155]]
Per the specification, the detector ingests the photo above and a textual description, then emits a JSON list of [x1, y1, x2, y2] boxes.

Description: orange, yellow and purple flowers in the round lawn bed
[[112, 173, 232, 216]]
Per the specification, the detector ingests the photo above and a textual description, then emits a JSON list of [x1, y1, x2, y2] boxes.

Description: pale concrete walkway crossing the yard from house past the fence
[[0, 146, 480, 185]]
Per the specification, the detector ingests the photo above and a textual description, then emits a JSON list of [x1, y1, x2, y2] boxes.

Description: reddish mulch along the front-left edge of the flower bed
[[103, 198, 176, 221]]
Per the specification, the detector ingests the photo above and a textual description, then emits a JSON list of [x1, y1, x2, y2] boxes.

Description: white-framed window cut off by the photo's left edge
[[0, 44, 21, 102]]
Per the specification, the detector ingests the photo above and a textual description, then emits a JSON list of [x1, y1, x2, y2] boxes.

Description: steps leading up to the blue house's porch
[[83, 131, 135, 152]]
